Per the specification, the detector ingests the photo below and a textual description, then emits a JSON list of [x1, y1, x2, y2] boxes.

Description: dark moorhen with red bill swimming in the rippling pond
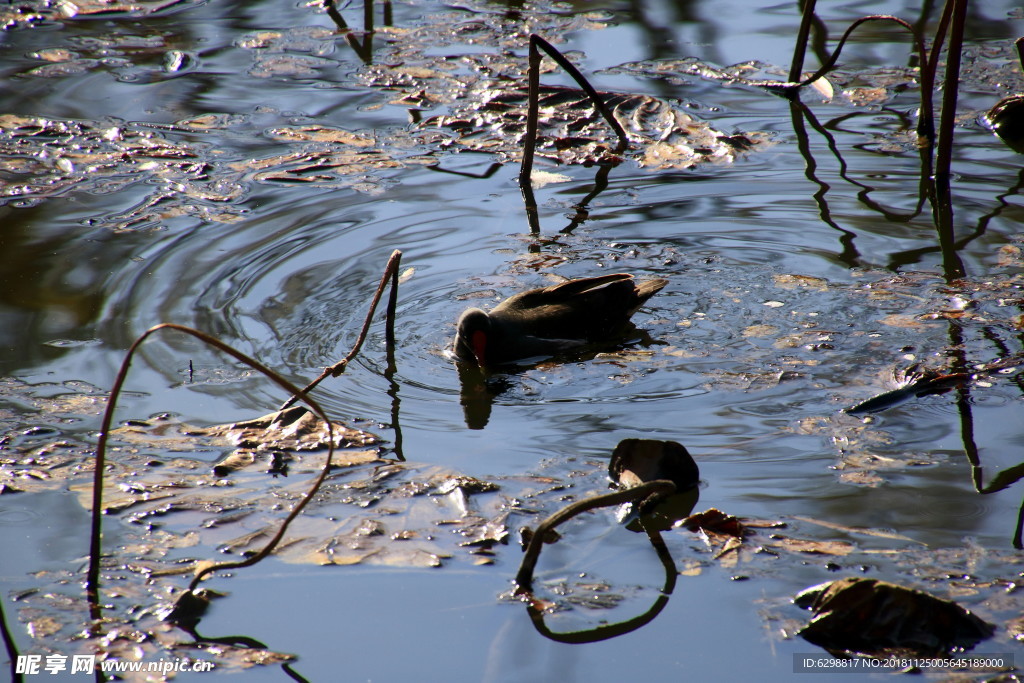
[[454, 272, 669, 368]]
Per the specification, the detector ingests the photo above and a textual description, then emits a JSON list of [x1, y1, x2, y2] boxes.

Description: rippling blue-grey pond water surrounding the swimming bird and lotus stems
[[0, 0, 1024, 681]]
